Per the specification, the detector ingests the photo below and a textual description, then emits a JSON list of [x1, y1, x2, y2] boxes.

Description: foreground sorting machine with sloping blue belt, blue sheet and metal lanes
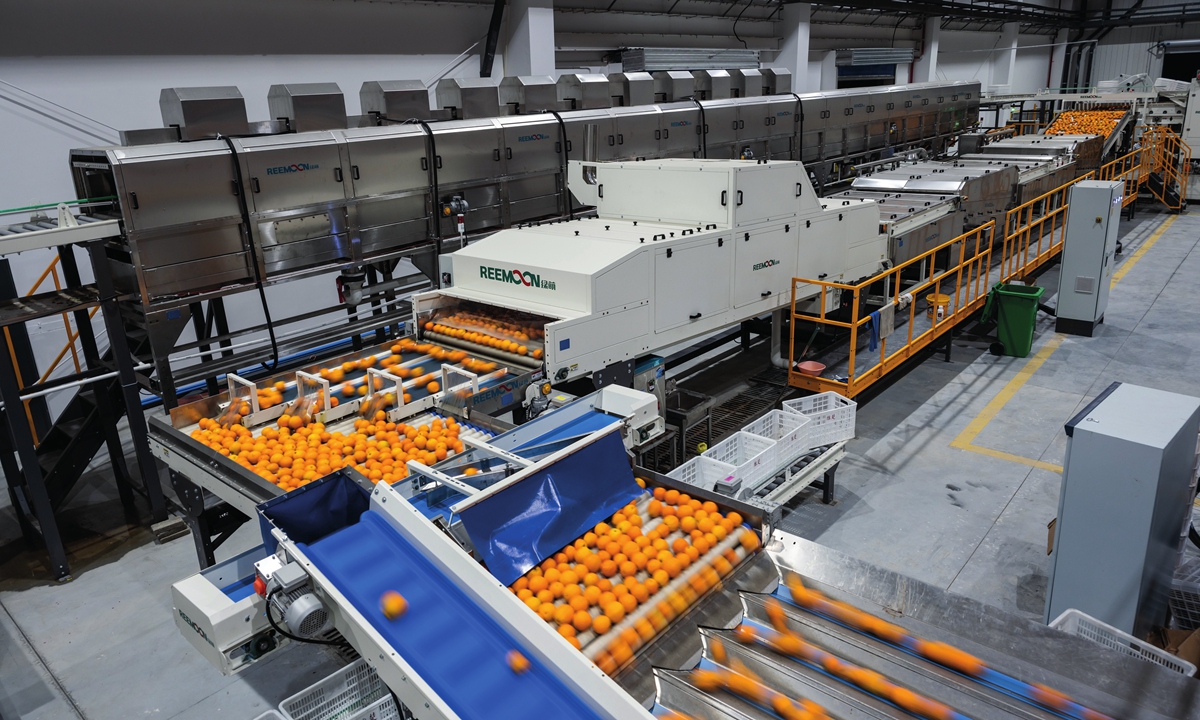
[[166, 397, 1190, 720]]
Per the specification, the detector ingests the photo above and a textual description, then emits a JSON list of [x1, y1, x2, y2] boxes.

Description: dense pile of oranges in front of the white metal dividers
[[192, 410, 463, 491]]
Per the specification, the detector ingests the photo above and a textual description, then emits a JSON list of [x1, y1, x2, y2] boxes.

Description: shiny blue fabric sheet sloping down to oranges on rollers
[[461, 432, 642, 584]]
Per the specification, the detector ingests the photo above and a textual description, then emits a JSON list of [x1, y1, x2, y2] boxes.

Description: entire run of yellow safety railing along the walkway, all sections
[[787, 124, 1192, 397]]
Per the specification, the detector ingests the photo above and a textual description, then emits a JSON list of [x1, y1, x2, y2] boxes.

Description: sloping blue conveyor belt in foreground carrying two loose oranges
[[301, 510, 599, 720]]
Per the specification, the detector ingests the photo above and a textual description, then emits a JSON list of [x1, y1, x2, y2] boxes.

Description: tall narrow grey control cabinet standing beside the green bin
[[1055, 180, 1124, 337]]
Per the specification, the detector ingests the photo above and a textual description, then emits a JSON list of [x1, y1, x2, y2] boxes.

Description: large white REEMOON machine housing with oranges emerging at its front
[[413, 158, 887, 382]]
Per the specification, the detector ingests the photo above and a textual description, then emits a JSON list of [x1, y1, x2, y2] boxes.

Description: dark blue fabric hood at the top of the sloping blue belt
[[258, 470, 371, 552]]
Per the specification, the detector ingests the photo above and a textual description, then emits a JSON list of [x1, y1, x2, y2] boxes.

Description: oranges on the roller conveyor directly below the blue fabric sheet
[[509, 480, 758, 674]]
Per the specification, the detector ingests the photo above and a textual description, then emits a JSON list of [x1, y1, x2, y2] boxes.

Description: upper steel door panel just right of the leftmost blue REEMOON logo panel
[[343, 126, 430, 198]]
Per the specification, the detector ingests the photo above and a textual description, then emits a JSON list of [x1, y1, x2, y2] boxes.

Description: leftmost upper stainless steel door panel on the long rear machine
[[116, 147, 241, 229]]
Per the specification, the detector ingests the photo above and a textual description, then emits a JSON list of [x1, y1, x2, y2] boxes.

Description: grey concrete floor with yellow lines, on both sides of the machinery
[[0, 205, 1200, 720]]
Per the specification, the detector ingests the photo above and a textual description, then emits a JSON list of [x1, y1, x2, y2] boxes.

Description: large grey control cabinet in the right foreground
[[1045, 383, 1200, 638]]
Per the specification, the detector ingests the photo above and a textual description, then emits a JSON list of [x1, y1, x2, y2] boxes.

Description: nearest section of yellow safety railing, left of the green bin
[[787, 220, 996, 397]]
